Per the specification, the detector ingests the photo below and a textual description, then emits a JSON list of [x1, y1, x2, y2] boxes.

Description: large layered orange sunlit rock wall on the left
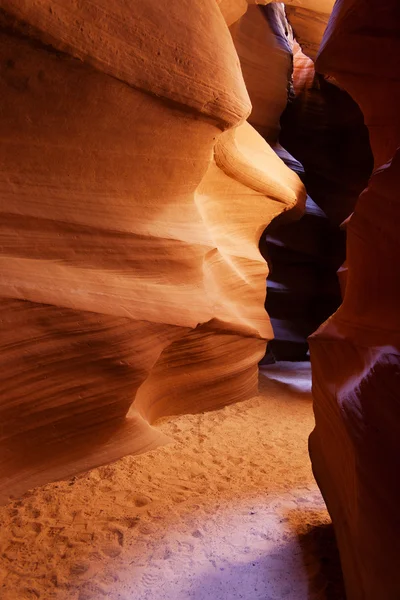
[[0, 0, 305, 497]]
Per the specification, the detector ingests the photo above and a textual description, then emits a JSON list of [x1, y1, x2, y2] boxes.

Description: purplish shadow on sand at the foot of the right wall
[[182, 515, 346, 600]]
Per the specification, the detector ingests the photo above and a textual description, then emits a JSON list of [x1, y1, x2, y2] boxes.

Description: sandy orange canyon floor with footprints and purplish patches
[[0, 363, 344, 600]]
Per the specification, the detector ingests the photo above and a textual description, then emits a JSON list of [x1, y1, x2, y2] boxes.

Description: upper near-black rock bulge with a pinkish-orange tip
[[281, 42, 373, 227]]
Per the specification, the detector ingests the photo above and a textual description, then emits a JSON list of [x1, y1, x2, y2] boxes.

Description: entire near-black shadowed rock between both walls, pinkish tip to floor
[[266, 41, 373, 360]]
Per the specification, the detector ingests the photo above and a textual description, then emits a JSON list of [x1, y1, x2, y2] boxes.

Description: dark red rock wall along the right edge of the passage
[[310, 0, 400, 600]]
